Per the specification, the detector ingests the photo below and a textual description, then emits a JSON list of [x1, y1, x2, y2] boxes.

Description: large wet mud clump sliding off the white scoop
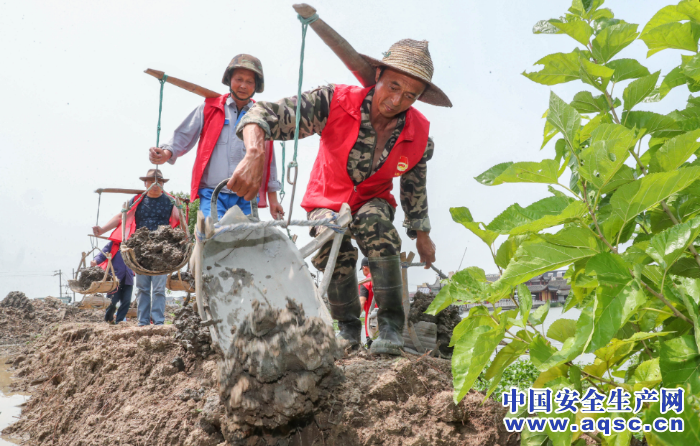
[[220, 299, 342, 444]]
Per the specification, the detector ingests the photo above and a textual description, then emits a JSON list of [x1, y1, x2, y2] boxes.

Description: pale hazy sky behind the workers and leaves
[[0, 0, 688, 298]]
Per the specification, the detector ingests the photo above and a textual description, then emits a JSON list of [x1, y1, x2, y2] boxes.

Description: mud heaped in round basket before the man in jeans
[[126, 226, 187, 271]]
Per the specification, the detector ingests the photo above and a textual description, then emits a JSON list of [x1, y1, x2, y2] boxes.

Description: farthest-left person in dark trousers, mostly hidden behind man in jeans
[[90, 241, 134, 324]]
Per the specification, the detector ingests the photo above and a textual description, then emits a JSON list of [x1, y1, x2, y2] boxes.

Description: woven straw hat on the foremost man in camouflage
[[360, 39, 452, 107]]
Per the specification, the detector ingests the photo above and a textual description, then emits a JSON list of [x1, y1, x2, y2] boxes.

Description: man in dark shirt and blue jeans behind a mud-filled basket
[[92, 169, 182, 327]]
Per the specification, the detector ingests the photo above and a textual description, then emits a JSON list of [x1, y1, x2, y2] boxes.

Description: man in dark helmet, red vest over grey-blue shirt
[[148, 54, 284, 219]]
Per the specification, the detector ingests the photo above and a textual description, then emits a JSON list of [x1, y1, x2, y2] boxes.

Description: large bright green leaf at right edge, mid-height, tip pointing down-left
[[603, 167, 700, 240]]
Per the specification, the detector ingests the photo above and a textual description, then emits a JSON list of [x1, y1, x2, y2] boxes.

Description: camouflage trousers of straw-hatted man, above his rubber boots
[[309, 198, 401, 280]]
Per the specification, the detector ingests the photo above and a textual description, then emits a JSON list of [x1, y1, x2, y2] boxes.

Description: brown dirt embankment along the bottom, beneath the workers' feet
[[5, 302, 520, 446]]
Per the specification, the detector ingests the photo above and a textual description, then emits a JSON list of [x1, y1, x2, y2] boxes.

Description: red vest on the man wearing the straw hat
[[301, 85, 430, 213]]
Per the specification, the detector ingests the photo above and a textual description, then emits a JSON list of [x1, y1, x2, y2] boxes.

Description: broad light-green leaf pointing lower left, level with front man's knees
[[494, 242, 597, 289]]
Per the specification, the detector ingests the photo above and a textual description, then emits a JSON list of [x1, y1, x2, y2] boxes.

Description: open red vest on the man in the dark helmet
[[190, 93, 274, 207]]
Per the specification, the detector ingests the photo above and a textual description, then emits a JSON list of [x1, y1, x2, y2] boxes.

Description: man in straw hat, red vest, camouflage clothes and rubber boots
[[228, 39, 452, 355]]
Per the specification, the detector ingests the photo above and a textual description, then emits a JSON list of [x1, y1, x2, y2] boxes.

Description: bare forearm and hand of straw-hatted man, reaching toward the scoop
[[226, 124, 265, 201]]
